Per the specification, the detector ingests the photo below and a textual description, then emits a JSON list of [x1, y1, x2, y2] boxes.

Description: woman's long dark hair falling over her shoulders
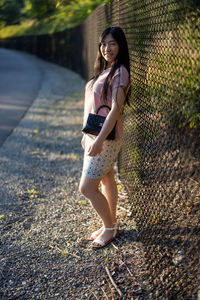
[[93, 26, 130, 103]]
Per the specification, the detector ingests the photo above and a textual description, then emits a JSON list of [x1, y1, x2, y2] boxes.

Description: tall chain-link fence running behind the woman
[[0, 0, 200, 299]]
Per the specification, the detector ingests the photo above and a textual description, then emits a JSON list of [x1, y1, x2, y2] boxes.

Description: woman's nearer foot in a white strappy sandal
[[91, 227, 119, 248]]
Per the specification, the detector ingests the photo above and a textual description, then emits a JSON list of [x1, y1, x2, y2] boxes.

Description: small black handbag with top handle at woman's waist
[[82, 105, 116, 140]]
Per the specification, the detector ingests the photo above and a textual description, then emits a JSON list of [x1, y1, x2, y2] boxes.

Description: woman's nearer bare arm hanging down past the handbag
[[88, 86, 126, 156]]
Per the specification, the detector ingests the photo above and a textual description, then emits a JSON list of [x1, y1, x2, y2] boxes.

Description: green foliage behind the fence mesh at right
[[147, 11, 200, 129]]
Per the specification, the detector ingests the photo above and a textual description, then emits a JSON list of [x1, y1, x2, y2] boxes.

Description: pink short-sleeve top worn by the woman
[[83, 65, 130, 139]]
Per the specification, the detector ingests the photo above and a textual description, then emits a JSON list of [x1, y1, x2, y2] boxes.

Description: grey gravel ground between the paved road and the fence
[[0, 61, 148, 300]]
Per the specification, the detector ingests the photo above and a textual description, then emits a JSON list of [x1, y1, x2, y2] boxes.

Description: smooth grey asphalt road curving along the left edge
[[0, 49, 43, 147]]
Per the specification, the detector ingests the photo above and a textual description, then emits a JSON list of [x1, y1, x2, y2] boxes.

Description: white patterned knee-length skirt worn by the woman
[[83, 135, 122, 179]]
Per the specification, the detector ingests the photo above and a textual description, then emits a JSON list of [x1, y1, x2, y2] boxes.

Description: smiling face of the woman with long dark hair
[[100, 34, 119, 67]]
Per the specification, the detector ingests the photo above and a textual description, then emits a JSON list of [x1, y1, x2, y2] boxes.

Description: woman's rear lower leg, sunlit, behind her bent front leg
[[102, 169, 118, 223]]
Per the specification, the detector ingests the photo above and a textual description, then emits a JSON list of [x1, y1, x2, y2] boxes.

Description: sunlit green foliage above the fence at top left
[[0, 0, 104, 38]]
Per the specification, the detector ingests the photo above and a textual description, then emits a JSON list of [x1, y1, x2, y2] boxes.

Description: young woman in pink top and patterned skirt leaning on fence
[[80, 26, 130, 248]]
